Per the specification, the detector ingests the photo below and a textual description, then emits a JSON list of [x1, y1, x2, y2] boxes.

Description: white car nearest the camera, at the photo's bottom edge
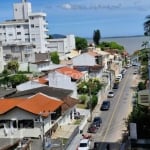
[[77, 139, 91, 150]]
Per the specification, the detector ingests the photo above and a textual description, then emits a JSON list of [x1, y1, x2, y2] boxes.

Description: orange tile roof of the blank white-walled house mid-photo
[[56, 67, 84, 80]]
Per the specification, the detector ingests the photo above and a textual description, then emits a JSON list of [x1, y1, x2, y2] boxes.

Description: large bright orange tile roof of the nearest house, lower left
[[0, 93, 64, 117]]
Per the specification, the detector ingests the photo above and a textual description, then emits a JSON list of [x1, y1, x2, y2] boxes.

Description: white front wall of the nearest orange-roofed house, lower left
[[0, 108, 52, 138]]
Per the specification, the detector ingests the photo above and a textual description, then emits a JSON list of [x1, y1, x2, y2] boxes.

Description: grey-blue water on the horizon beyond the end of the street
[[88, 36, 150, 55]]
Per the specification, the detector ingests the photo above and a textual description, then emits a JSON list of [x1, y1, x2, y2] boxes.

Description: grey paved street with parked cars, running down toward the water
[[67, 67, 136, 150]]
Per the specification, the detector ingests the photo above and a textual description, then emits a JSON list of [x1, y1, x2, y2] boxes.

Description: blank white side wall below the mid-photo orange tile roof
[[48, 72, 77, 98]]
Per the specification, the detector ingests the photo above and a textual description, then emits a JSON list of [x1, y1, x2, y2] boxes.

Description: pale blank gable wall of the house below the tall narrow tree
[[72, 53, 96, 66]]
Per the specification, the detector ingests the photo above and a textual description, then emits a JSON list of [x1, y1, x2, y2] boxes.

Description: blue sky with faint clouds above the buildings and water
[[0, 0, 150, 38]]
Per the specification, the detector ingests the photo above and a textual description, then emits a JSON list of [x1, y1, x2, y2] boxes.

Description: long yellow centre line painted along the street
[[100, 69, 129, 149]]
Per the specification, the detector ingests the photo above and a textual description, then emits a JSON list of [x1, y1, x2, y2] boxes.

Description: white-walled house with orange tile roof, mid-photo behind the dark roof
[[48, 67, 84, 98]]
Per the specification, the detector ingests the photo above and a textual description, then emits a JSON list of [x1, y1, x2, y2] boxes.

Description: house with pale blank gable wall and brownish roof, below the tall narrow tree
[[72, 52, 104, 78]]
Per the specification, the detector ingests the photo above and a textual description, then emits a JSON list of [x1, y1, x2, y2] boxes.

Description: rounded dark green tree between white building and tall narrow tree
[[75, 37, 88, 51]]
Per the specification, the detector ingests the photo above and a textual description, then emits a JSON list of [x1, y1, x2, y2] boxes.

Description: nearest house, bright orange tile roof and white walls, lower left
[[0, 93, 63, 138]]
